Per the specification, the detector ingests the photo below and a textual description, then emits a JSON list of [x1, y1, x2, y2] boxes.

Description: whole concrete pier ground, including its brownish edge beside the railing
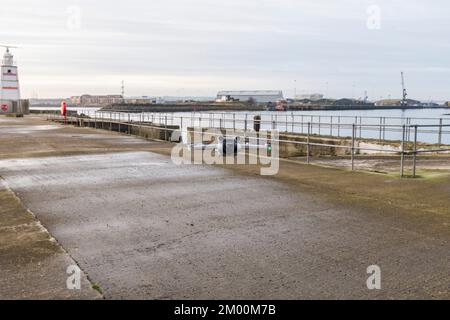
[[0, 116, 450, 299]]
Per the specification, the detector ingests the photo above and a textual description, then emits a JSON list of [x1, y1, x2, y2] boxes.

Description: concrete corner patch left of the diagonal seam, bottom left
[[0, 181, 102, 300]]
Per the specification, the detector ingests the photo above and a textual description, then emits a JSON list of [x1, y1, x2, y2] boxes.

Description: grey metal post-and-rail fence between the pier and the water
[[47, 110, 450, 177]]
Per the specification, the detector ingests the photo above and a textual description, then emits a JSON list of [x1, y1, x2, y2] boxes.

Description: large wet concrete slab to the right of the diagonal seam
[[0, 115, 450, 299]]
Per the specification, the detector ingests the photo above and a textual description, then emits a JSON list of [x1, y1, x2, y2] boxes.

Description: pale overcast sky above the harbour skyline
[[0, 0, 450, 100]]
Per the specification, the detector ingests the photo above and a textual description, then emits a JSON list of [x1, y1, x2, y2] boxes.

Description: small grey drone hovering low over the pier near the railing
[[188, 136, 272, 156]]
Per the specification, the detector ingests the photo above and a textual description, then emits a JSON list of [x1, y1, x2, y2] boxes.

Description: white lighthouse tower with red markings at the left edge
[[0, 46, 20, 113]]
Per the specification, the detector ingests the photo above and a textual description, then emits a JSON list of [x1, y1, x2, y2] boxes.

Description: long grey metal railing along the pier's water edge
[[47, 111, 450, 177]]
